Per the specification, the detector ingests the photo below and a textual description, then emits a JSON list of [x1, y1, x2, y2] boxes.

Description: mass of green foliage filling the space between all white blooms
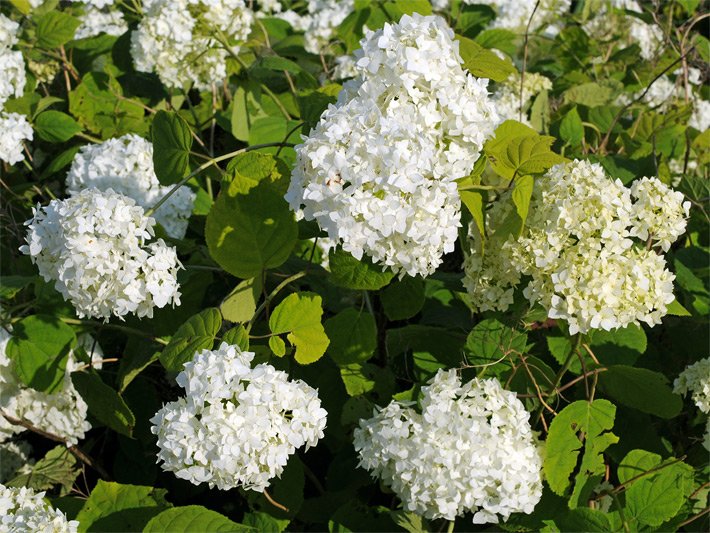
[[0, 0, 710, 531]]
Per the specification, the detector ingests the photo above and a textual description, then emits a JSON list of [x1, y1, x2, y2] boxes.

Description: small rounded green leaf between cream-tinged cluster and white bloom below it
[[464, 318, 528, 375]]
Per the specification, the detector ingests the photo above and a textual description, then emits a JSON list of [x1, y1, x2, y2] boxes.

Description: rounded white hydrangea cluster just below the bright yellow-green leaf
[[150, 343, 327, 492]]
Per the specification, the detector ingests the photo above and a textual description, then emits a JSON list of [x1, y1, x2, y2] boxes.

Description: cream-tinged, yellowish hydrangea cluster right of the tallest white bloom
[[464, 161, 690, 334]]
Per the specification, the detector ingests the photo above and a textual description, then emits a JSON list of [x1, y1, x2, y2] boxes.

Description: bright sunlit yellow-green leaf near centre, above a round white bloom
[[269, 292, 330, 365]]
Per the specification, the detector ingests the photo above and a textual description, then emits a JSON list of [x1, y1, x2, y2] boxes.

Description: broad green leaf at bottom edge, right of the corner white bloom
[[76, 479, 170, 533]]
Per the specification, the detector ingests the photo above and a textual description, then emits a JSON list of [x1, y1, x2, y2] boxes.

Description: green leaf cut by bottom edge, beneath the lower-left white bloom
[[143, 505, 250, 533]]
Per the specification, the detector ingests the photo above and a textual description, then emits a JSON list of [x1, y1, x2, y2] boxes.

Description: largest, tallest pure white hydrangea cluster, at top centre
[[286, 14, 498, 276]]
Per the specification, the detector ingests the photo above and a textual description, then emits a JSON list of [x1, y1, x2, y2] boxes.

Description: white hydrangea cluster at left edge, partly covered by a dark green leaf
[[0, 329, 102, 445]]
